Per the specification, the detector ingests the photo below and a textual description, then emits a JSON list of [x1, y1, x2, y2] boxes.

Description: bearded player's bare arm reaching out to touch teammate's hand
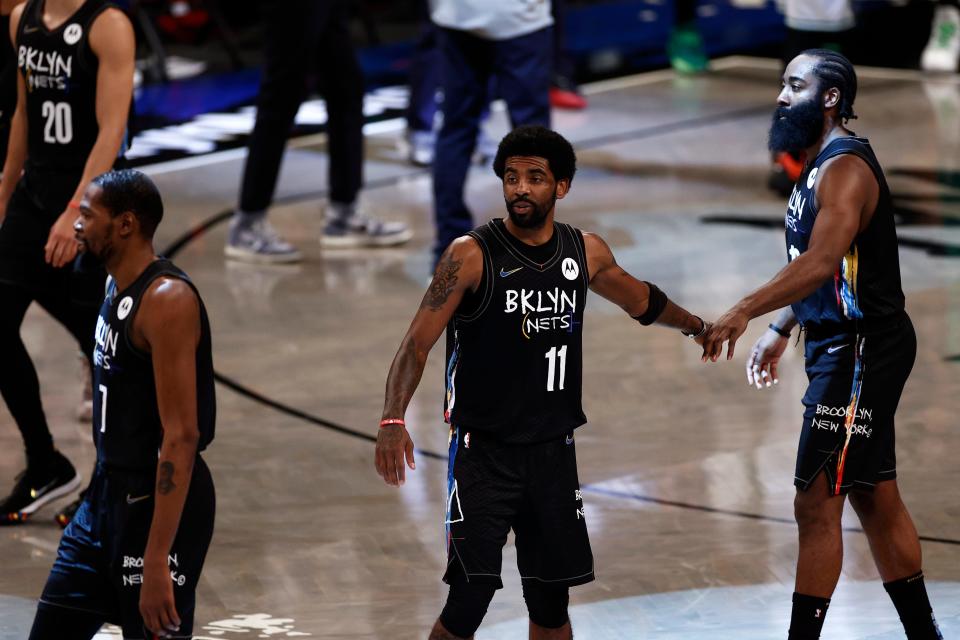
[[703, 155, 879, 362]]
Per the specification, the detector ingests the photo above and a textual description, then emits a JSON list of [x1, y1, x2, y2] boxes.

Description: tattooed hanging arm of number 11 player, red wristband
[[374, 236, 483, 486]]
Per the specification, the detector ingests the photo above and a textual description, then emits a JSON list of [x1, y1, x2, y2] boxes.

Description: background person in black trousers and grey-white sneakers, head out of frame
[[224, 0, 413, 263]]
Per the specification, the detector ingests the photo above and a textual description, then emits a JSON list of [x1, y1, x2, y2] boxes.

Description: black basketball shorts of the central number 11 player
[[443, 428, 594, 589]]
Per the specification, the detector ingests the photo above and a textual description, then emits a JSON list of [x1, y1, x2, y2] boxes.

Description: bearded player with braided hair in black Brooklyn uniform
[[703, 49, 941, 640]]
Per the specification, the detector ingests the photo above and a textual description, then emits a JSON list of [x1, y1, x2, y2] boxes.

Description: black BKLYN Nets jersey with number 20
[[16, 0, 115, 173]]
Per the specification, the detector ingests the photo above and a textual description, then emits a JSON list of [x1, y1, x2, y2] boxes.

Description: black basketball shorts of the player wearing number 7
[[38, 457, 216, 640]]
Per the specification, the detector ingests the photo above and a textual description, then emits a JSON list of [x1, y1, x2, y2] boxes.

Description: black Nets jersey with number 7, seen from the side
[[93, 258, 216, 470]]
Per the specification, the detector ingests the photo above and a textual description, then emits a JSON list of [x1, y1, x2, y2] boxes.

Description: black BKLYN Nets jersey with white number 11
[[446, 220, 589, 443]]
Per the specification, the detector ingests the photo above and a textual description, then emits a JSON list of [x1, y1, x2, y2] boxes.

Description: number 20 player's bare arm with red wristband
[[45, 9, 136, 268]]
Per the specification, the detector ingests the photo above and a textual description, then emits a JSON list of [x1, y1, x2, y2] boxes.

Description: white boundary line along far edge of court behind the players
[[141, 55, 960, 176]]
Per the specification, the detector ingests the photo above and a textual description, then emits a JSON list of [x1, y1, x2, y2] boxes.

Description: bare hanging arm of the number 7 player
[[134, 278, 200, 635]]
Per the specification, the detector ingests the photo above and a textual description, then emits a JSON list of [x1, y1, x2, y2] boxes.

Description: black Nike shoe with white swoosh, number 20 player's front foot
[[0, 451, 80, 524]]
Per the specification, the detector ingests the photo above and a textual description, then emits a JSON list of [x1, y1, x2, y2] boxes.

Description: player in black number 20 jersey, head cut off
[[0, 0, 135, 523]]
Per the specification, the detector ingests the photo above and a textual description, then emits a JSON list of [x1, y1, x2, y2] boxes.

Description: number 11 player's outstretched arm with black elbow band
[[583, 233, 704, 334]]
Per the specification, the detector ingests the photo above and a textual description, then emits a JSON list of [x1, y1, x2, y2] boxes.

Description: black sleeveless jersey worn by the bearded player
[[786, 136, 904, 328]]
